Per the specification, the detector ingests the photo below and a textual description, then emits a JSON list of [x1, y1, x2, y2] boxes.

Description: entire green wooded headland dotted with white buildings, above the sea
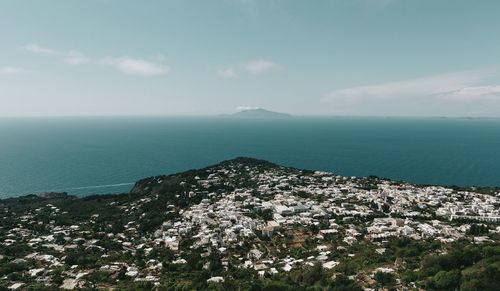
[[0, 158, 500, 290]]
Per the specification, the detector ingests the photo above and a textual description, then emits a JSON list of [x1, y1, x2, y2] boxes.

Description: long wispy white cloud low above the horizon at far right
[[323, 70, 500, 115]]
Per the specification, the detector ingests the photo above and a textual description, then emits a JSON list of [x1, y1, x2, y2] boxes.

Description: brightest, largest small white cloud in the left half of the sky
[[102, 57, 170, 76]]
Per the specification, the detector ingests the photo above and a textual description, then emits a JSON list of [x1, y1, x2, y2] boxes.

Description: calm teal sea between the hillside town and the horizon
[[0, 118, 500, 197]]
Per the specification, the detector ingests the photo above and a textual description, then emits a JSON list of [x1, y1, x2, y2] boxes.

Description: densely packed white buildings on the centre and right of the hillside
[[148, 164, 500, 274]]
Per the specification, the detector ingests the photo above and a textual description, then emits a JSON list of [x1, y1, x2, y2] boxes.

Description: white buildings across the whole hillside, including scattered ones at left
[[0, 162, 500, 289]]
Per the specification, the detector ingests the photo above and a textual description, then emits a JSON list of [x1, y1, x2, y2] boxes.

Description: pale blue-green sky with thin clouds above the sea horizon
[[0, 0, 500, 117]]
